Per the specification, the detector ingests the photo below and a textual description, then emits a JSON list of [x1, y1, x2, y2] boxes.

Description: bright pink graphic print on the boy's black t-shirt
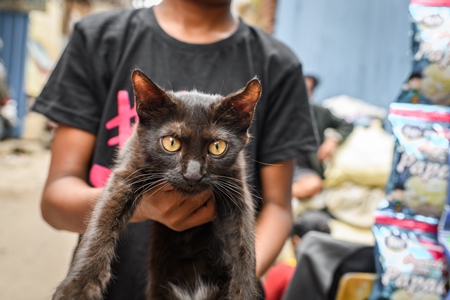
[[89, 90, 138, 187]]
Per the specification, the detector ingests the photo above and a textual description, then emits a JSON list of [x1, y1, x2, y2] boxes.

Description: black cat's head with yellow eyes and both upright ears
[[132, 71, 261, 194]]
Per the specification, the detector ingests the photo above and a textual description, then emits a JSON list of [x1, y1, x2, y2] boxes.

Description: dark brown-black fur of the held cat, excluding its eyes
[[53, 70, 261, 300]]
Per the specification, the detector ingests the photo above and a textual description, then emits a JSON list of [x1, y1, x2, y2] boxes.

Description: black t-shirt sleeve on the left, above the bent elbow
[[32, 26, 101, 134]]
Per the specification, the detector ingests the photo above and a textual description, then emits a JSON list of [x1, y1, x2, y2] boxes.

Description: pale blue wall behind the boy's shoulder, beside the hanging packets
[[274, 0, 411, 108]]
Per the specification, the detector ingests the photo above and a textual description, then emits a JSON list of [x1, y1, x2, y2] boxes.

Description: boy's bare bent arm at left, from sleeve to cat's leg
[[41, 125, 101, 233]]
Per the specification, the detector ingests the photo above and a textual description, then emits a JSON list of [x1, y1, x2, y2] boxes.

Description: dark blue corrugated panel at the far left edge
[[0, 10, 28, 137]]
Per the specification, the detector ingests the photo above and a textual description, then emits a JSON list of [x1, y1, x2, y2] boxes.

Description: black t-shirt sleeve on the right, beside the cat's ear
[[260, 64, 317, 163]]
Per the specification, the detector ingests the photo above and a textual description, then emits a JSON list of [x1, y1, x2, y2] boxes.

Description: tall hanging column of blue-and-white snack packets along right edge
[[369, 0, 450, 300]]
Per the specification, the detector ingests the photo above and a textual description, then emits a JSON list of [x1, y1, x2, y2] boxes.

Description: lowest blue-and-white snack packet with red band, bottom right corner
[[369, 203, 447, 300]]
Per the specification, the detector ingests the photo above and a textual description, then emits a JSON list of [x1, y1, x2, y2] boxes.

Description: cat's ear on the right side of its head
[[222, 77, 262, 120]]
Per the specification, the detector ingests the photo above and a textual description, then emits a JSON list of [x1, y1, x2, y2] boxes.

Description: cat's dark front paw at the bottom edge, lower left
[[52, 282, 103, 300]]
